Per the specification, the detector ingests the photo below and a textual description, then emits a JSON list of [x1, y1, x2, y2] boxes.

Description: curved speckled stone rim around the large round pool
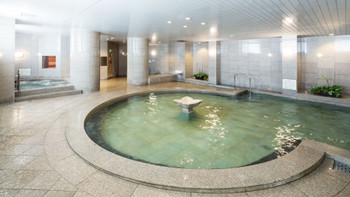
[[65, 89, 350, 193]]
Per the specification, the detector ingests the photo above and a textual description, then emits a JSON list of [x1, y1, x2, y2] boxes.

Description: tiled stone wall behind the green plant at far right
[[298, 35, 350, 94]]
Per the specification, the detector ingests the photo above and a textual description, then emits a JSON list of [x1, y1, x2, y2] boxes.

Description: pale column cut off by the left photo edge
[[0, 17, 15, 104]]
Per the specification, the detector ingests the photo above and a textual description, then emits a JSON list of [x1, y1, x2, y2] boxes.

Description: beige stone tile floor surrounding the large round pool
[[0, 79, 350, 197]]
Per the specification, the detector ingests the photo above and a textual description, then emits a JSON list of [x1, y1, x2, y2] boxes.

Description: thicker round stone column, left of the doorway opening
[[70, 29, 100, 92]]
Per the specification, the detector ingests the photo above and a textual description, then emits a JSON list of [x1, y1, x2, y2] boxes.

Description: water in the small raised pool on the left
[[15, 80, 69, 90]]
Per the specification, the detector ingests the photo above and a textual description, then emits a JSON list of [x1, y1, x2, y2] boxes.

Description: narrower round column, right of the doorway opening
[[127, 37, 149, 85]]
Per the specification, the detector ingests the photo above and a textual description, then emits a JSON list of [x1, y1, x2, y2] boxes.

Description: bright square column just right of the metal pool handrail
[[282, 36, 298, 95]]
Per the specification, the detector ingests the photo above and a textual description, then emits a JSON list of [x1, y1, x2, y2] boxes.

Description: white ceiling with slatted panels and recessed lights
[[0, 0, 350, 42]]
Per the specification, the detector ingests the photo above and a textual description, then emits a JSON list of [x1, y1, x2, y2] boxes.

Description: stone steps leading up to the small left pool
[[15, 85, 82, 102]]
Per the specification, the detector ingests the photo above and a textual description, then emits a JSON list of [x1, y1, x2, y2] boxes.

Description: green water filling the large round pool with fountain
[[86, 94, 350, 169]]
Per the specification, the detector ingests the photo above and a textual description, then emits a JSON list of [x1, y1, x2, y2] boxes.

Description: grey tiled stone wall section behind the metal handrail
[[220, 38, 282, 92]]
